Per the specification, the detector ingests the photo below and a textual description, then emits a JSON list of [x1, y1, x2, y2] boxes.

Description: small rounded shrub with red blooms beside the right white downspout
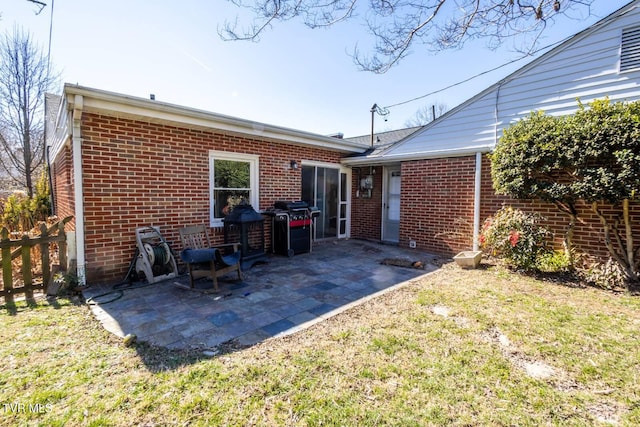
[[480, 206, 552, 270]]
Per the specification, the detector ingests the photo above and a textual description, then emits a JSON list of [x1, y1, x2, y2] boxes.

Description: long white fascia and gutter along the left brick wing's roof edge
[[64, 84, 368, 153]]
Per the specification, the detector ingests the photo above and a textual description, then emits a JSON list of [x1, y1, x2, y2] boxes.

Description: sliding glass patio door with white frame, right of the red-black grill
[[302, 163, 350, 239]]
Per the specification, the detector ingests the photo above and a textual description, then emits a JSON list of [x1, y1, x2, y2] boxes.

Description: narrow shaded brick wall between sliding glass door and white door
[[351, 166, 384, 240]]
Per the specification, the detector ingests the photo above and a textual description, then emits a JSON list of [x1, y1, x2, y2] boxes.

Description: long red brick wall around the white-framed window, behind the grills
[[73, 113, 340, 283]]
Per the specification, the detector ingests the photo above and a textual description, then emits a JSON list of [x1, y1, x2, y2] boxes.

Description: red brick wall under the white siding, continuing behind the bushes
[[390, 156, 640, 258]]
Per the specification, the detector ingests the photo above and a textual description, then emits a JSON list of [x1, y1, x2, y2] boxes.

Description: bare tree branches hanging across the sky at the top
[[224, 0, 594, 73]]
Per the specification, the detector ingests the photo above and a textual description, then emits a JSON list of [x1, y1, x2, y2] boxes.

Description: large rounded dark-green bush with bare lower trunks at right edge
[[491, 99, 640, 285]]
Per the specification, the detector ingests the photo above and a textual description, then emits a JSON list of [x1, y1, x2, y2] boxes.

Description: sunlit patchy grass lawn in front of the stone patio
[[0, 264, 640, 426]]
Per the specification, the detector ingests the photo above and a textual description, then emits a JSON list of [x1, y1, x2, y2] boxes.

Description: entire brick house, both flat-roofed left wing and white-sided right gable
[[46, 0, 640, 283]]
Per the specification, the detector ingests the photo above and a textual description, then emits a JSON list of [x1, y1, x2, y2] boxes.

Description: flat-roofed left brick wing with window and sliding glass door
[[47, 85, 367, 283]]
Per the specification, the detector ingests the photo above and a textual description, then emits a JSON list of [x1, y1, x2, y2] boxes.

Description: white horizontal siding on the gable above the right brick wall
[[384, 2, 640, 161]]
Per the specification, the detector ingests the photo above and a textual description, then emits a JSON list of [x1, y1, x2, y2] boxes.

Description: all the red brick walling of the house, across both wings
[[53, 113, 640, 283]]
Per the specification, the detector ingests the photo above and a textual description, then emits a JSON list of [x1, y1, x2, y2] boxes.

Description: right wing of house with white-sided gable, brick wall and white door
[[342, 0, 640, 256]]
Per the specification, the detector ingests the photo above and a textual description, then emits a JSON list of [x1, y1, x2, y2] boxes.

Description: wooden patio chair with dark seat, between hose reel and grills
[[180, 225, 242, 292]]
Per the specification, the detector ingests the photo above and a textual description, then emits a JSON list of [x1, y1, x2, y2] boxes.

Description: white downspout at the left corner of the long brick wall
[[72, 95, 87, 286]]
